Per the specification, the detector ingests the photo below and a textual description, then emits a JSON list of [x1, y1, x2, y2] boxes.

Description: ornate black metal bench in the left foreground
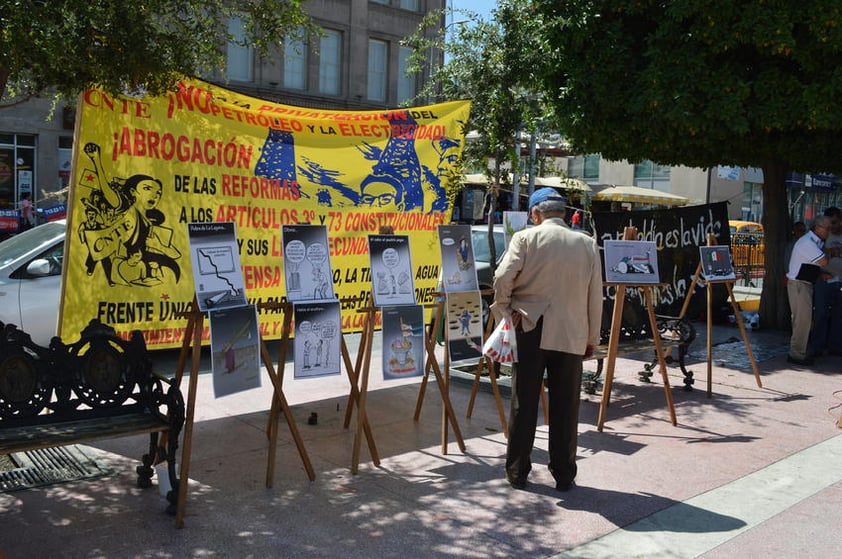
[[0, 320, 185, 514]]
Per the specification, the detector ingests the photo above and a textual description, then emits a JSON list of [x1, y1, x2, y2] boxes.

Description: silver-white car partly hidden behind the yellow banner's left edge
[[0, 219, 67, 347]]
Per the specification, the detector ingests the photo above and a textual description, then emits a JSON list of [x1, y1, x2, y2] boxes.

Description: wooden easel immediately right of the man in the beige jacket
[[596, 227, 678, 432]]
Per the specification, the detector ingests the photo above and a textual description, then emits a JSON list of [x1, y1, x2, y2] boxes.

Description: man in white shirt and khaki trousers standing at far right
[[786, 215, 831, 365]]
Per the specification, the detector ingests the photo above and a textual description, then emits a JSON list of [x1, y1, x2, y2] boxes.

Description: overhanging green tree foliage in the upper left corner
[[0, 0, 316, 99]]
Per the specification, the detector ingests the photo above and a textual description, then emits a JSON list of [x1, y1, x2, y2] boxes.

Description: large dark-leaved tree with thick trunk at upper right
[[531, 0, 842, 328]]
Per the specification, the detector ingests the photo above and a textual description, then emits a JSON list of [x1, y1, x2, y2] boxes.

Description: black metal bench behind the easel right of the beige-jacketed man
[[582, 307, 696, 394]]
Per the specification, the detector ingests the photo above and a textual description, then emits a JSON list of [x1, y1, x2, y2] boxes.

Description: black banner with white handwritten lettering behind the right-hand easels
[[593, 202, 731, 324]]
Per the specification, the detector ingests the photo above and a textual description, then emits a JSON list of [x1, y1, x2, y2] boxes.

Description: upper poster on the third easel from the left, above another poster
[[368, 235, 415, 307]]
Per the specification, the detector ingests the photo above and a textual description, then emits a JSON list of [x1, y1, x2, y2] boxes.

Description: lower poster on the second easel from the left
[[293, 301, 342, 378]]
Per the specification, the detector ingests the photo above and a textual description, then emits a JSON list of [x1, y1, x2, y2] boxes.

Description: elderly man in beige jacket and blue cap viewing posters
[[491, 188, 602, 491]]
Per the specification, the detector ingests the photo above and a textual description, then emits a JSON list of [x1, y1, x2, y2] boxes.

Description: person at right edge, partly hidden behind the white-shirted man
[[809, 207, 842, 357]]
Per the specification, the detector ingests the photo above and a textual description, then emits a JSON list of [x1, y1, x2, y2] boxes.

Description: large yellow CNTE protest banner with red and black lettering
[[60, 76, 470, 348]]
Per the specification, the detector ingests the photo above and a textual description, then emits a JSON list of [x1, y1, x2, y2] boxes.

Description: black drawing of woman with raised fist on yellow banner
[[80, 143, 181, 287]]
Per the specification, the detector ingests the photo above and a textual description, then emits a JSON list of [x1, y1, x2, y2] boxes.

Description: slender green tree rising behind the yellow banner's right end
[[405, 0, 546, 268]]
